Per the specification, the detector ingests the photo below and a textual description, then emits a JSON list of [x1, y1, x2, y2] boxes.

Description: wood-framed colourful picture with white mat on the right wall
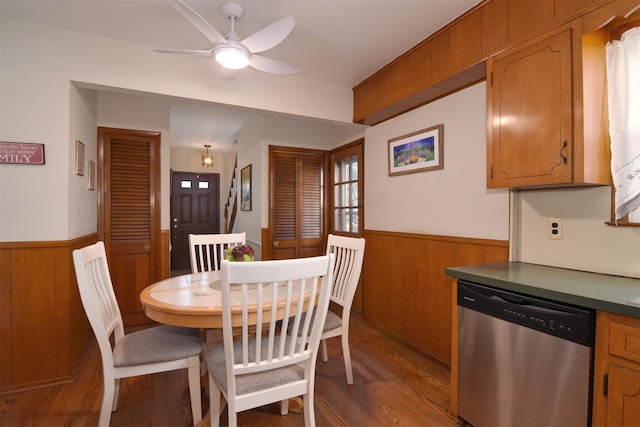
[[388, 124, 444, 176]]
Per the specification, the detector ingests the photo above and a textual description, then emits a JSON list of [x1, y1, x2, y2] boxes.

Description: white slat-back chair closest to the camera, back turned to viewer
[[204, 255, 335, 427]]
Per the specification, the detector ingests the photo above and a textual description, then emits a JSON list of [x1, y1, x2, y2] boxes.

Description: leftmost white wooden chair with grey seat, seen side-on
[[73, 242, 202, 427]]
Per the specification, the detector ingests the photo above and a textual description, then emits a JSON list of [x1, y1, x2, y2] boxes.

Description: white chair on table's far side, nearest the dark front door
[[189, 232, 247, 273]]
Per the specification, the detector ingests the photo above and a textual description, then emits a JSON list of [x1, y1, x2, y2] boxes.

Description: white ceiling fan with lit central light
[[154, 0, 300, 74]]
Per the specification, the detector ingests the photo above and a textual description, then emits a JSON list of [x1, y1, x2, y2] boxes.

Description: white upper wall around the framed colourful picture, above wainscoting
[[364, 83, 509, 240]]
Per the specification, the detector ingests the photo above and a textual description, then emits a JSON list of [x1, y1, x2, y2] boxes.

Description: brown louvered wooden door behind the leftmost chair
[[98, 127, 161, 326]]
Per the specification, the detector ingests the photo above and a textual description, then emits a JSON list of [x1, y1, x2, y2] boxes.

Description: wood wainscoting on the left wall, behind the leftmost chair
[[0, 234, 97, 394]]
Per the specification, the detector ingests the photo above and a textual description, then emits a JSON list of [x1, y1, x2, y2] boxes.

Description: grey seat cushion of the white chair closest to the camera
[[204, 337, 304, 395]]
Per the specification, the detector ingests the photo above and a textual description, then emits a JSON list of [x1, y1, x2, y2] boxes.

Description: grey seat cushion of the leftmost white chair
[[113, 325, 202, 367]]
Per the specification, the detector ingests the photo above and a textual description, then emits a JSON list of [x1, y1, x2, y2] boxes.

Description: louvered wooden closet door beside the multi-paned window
[[269, 147, 327, 259]]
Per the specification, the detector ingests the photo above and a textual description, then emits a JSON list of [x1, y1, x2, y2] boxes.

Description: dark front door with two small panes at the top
[[171, 172, 220, 270]]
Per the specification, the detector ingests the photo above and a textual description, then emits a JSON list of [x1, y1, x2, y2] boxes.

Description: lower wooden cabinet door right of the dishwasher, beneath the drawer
[[607, 364, 640, 427]]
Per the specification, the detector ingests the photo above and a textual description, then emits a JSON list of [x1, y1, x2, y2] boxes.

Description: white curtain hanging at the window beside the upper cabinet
[[606, 27, 640, 220]]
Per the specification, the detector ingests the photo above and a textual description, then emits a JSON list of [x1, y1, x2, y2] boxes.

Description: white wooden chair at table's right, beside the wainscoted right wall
[[321, 234, 365, 384]]
